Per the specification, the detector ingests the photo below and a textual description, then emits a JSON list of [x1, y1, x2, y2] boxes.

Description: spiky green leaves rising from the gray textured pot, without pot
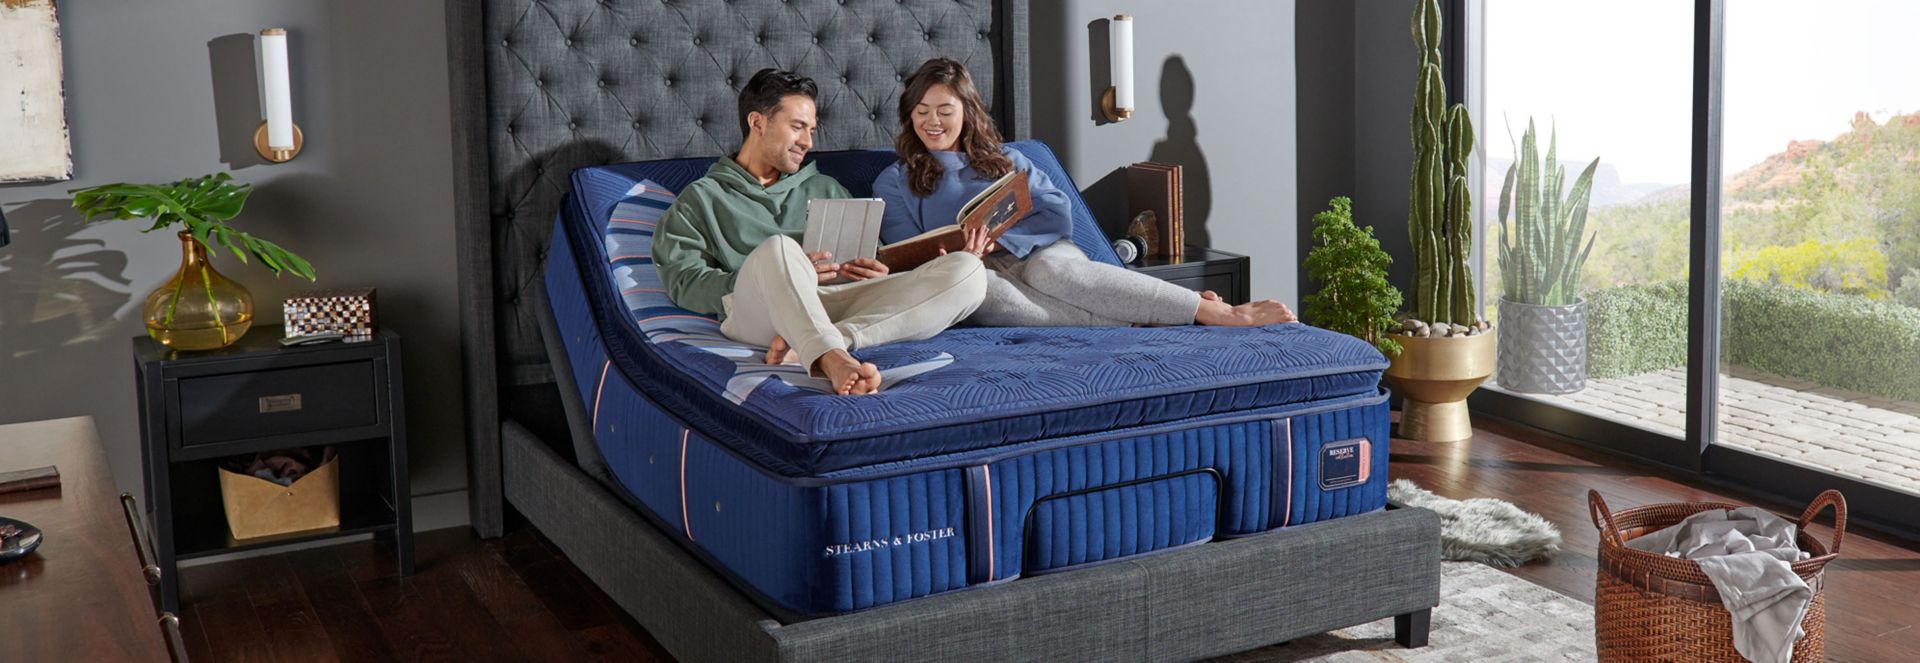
[[1498, 119, 1599, 306]]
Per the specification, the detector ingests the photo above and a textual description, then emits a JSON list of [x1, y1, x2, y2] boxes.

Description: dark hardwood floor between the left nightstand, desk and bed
[[180, 528, 672, 661]]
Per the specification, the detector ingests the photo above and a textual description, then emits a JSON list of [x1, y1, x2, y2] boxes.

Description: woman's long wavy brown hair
[[893, 58, 1014, 198]]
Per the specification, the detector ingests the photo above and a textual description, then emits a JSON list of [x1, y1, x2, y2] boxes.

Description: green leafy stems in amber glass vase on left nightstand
[[69, 173, 313, 350]]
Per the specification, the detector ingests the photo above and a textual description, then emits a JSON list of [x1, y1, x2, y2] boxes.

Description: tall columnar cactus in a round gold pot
[[1386, 0, 1494, 442]]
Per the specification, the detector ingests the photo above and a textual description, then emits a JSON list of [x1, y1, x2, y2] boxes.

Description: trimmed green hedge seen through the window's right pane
[[1720, 281, 1920, 400]]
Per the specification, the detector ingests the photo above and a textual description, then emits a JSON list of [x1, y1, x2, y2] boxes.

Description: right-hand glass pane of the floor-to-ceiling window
[[1715, 0, 1920, 492]]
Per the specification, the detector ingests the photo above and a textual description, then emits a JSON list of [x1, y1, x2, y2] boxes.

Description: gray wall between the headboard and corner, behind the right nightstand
[[1031, 0, 1304, 306]]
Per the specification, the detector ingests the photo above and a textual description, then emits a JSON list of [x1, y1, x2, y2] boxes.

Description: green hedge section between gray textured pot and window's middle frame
[[1586, 281, 1686, 379]]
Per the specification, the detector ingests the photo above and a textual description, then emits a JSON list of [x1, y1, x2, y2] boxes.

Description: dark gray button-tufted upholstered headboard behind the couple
[[445, 0, 1031, 532]]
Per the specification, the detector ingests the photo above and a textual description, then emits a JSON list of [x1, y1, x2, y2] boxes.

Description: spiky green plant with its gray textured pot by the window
[[1498, 119, 1599, 394]]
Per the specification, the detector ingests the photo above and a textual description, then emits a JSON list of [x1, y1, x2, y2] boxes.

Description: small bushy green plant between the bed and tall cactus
[[1306, 196, 1400, 357]]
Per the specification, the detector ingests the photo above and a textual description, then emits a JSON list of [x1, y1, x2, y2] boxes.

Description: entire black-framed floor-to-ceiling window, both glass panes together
[[1452, 0, 1920, 527]]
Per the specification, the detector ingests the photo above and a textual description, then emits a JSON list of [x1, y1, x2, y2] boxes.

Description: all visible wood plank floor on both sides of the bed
[[180, 421, 1920, 661]]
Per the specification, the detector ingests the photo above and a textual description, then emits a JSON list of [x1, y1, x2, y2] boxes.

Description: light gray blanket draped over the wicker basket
[[1626, 507, 1812, 663]]
